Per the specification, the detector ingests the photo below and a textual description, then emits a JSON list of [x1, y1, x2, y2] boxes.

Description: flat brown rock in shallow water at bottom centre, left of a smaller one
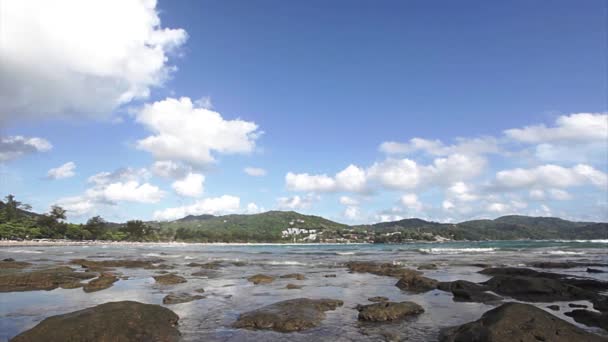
[[233, 298, 344, 332]]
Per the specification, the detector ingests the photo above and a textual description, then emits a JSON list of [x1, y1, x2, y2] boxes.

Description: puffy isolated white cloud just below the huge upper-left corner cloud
[[137, 97, 261, 166]]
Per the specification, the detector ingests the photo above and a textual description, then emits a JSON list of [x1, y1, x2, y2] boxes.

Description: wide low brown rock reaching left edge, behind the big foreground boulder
[[0, 266, 96, 292]]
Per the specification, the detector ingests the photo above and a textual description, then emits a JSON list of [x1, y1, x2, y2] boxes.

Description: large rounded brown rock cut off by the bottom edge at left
[[11, 301, 180, 342]]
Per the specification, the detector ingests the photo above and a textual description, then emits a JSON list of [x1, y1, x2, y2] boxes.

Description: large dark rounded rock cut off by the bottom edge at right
[[439, 303, 606, 342]]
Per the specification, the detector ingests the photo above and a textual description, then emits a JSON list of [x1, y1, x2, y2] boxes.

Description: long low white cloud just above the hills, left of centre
[[154, 195, 241, 221]]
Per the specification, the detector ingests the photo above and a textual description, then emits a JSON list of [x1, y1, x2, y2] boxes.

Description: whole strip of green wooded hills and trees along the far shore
[[0, 195, 608, 243]]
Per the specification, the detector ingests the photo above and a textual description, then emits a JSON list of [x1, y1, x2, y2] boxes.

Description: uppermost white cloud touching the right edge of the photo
[[505, 113, 608, 143]]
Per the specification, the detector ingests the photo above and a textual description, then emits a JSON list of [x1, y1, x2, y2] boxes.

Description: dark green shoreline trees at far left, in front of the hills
[[0, 195, 164, 241]]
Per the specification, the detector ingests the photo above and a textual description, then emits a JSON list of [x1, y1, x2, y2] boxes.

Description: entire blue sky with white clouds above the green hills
[[0, 0, 608, 224]]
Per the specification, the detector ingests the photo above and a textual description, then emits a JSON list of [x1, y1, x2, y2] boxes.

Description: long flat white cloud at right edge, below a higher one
[[496, 164, 608, 189]]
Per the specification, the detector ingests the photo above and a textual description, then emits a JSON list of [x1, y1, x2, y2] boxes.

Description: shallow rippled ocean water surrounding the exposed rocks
[[0, 240, 608, 341]]
